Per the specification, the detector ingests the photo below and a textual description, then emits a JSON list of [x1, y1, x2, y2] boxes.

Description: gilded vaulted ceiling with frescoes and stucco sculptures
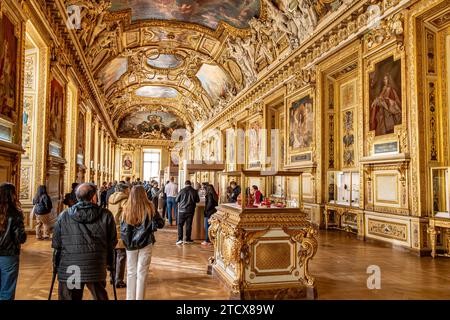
[[65, 0, 342, 139]]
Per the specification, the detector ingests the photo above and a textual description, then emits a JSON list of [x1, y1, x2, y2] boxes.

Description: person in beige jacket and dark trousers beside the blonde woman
[[108, 183, 130, 288]]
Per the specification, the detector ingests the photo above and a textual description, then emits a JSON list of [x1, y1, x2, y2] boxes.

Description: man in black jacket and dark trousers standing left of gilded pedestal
[[175, 180, 200, 244]]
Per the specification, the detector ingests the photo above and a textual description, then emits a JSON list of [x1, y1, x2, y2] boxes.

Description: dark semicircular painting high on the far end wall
[[118, 111, 186, 139]]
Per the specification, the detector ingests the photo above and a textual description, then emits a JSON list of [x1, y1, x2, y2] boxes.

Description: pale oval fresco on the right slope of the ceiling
[[197, 63, 231, 100]]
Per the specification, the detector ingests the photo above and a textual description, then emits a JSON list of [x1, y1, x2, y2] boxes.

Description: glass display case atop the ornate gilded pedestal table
[[219, 170, 302, 211]]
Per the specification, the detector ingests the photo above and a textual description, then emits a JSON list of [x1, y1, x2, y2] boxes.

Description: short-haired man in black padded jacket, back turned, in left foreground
[[52, 183, 117, 300]]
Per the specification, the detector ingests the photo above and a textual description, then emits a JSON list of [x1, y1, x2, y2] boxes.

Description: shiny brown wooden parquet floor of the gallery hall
[[16, 228, 450, 300]]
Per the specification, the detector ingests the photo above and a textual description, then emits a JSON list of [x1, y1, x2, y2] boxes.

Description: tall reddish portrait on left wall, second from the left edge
[[50, 80, 64, 143]]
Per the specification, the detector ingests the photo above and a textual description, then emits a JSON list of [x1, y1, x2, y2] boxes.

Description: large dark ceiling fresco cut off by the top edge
[[111, 0, 260, 29]]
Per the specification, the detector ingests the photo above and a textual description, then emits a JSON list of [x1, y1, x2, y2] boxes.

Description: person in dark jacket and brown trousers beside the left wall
[[33, 185, 53, 240]]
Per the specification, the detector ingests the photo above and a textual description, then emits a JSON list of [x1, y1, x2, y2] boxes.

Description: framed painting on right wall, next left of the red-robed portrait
[[286, 90, 314, 165]]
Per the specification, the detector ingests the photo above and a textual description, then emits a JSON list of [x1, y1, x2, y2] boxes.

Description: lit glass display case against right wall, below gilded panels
[[328, 171, 359, 207]]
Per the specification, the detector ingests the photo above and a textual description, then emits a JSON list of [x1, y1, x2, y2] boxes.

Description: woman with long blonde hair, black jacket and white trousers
[[120, 185, 164, 300]]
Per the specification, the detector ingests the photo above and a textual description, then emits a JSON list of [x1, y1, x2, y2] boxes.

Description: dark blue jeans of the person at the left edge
[[0, 256, 19, 300]]
